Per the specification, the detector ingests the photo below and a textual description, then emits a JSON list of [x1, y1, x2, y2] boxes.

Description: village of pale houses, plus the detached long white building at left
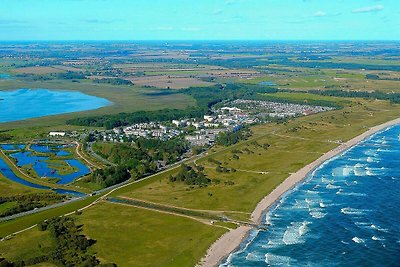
[[50, 99, 334, 151]]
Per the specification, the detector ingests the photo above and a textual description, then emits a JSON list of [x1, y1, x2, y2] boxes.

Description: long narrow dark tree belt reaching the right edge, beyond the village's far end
[[309, 90, 400, 104]]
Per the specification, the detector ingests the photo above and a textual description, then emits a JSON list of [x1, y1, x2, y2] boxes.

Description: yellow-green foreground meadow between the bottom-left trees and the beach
[[77, 203, 225, 267]]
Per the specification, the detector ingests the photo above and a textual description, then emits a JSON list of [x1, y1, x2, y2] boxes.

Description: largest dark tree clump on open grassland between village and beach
[[169, 164, 211, 185]]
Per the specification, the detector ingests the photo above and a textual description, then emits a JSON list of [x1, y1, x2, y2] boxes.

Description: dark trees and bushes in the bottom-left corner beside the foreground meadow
[[0, 217, 116, 267]]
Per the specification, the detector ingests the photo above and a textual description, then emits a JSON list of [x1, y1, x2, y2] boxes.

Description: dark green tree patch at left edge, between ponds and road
[[0, 193, 65, 217]]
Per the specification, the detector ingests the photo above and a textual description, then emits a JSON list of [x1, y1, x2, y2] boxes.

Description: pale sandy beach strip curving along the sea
[[202, 118, 400, 267]]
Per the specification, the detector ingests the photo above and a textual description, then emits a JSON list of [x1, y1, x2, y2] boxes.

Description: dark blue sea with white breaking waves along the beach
[[222, 126, 400, 266]]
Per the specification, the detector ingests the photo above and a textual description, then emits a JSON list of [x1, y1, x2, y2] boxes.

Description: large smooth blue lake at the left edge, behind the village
[[0, 89, 111, 123]]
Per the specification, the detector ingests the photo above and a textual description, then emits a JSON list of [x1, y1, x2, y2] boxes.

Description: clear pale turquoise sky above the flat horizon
[[0, 0, 400, 40]]
